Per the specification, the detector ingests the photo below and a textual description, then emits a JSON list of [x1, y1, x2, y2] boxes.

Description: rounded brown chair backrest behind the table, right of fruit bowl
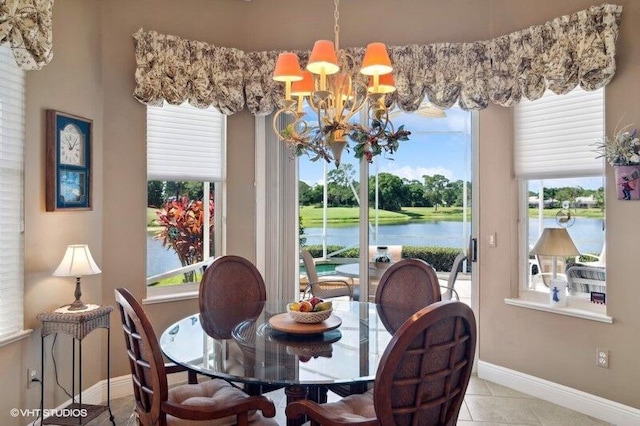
[[375, 259, 441, 333]]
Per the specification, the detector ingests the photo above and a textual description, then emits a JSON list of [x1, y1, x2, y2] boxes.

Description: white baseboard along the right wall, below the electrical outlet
[[478, 361, 640, 426]]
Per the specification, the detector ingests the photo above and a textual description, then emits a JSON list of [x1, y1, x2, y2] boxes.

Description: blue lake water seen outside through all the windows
[[147, 217, 604, 276]]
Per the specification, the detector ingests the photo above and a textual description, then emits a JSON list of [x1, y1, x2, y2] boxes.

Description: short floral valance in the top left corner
[[0, 0, 53, 70]]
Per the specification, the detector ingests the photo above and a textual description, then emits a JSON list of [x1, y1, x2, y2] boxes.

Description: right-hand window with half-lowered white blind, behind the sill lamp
[[514, 88, 605, 307]]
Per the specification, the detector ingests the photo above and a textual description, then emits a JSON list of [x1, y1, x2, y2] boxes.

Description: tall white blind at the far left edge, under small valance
[[0, 43, 25, 341]]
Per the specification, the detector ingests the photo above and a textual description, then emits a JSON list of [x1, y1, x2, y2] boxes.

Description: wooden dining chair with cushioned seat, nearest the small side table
[[115, 288, 277, 426]]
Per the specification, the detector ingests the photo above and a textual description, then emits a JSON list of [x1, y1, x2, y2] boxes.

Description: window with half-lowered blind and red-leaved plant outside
[[147, 103, 226, 296]]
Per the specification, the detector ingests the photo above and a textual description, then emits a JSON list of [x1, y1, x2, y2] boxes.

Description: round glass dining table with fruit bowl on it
[[160, 300, 410, 425]]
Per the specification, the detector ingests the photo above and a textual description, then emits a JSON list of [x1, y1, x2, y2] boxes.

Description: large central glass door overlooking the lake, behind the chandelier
[[298, 101, 473, 297]]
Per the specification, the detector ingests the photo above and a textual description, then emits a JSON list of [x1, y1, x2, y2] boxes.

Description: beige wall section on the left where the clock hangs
[[0, 0, 104, 425]]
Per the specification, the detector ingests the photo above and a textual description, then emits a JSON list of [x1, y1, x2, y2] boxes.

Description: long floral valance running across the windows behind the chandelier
[[134, 4, 622, 115]]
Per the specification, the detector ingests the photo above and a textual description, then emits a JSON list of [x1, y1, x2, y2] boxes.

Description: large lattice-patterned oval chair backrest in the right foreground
[[373, 301, 476, 426]]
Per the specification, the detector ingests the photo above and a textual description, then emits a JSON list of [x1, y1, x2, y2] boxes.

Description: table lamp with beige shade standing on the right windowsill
[[531, 228, 580, 306]]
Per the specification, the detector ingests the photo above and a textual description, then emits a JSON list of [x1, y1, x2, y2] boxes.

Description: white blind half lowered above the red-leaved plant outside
[[147, 103, 226, 182]]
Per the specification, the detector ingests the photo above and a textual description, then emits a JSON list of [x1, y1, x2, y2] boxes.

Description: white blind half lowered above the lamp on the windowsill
[[514, 87, 604, 179]]
